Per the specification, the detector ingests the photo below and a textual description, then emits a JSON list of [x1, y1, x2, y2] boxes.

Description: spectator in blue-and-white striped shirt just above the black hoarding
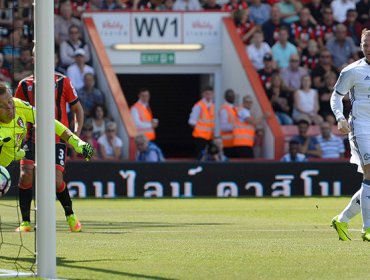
[[317, 122, 345, 158]]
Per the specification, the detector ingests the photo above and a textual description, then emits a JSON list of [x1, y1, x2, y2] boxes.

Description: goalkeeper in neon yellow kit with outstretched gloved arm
[[0, 82, 94, 231]]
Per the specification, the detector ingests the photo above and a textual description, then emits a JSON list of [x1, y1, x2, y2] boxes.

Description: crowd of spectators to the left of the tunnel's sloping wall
[[0, 0, 123, 160]]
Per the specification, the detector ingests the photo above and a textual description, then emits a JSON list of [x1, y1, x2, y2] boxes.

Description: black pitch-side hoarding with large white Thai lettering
[[4, 162, 362, 198]]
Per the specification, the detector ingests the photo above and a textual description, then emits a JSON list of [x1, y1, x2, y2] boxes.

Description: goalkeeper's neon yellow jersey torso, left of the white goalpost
[[0, 98, 35, 167]]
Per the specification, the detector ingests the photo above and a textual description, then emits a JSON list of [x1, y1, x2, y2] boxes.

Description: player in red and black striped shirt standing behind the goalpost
[[15, 72, 84, 231]]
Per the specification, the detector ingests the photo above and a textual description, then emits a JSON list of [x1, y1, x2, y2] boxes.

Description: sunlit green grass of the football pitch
[[0, 198, 370, 279]]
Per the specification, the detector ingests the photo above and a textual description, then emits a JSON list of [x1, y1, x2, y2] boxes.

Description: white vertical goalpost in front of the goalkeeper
[[34, 0, 56, 279]]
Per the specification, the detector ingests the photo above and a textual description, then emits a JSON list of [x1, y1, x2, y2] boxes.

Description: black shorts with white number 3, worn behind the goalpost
[[21, 141, 67, 171]]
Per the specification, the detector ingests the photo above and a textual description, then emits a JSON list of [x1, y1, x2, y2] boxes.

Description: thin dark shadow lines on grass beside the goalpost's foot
[[57, 257, 176, 280]]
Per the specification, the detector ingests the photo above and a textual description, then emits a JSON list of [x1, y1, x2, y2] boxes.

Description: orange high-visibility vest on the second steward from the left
[[192, 99, 215, 140]]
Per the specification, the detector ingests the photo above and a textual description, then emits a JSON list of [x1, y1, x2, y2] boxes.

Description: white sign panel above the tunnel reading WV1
[[83, 12, 230, 46]]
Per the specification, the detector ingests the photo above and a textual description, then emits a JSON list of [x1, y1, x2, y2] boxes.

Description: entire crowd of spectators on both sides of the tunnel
[[0, 0, 370, 160]]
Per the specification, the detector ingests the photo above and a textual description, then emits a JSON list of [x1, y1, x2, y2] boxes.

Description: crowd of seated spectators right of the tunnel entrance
[[232, 0, 370, 128]]
